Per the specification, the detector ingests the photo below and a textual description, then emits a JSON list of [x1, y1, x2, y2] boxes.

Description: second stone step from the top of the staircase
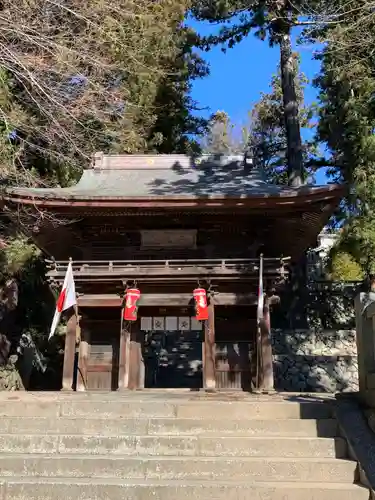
[[1, 417, 338, 437]]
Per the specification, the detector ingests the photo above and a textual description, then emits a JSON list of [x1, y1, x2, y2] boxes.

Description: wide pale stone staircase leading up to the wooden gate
[[0, 391, 369, 500]]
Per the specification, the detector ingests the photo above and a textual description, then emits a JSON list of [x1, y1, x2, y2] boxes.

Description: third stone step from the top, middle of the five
[[0, 434, 347, 458]]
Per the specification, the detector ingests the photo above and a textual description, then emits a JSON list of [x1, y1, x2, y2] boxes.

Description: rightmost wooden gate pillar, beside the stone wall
[[258, 297, 275, 392]]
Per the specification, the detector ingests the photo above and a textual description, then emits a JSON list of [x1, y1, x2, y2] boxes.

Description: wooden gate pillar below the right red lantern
[[203, 297, 216, 391]]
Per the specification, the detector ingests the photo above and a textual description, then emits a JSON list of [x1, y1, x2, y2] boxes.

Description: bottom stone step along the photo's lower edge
[[0, 477, 369, 500]]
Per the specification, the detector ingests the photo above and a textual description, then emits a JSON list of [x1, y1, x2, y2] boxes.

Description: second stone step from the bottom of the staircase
[[0, 454, 356, 484]]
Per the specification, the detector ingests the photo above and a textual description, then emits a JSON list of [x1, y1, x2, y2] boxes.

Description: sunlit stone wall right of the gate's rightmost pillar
[[272, 329, 358, 392]]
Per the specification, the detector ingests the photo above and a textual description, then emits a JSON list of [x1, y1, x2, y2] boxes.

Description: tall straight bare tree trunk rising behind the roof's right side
[[279, 29, 303, 187]]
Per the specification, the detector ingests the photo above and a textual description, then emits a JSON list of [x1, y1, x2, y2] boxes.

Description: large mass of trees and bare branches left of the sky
[[0, 0, 207, 185]]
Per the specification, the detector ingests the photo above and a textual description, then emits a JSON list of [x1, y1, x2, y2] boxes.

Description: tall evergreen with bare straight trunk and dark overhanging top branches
[[192, 0, 312, 186]]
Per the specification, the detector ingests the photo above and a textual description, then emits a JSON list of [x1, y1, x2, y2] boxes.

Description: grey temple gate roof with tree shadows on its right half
[[7, 153, 343, 205]]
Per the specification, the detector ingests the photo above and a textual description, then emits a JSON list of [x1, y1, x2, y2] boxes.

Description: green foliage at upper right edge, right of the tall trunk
[[315, 26, 375, 188]]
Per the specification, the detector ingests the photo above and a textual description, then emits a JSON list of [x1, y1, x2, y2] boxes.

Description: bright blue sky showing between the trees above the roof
[[189, 21, 326, 184]]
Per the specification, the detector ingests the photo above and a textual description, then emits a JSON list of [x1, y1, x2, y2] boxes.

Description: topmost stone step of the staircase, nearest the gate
[[0, 397, 332, 420]]
